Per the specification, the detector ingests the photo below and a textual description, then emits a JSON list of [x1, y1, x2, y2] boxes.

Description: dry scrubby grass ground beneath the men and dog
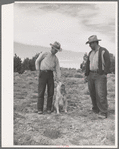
[[14, 70, 115, 146]]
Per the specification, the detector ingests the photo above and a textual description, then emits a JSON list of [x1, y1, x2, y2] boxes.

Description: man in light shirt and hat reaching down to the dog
[[35, 42, 62, 114]]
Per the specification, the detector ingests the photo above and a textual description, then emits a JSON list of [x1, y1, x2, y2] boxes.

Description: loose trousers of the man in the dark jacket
[[88, 72, 108, 113]]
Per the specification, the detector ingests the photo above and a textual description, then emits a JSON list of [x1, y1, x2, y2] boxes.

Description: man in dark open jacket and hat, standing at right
[[85, 35, 110, 118]]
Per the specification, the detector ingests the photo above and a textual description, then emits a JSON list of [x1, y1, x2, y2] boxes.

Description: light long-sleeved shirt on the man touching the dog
[[35, 52, 61, 79]]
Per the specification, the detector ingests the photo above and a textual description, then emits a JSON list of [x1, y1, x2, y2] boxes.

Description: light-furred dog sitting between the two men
[[53, 82, 67, 114]]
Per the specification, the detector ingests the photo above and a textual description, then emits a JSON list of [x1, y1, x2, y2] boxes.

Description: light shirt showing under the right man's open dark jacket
[[89, 46, 105, 70]]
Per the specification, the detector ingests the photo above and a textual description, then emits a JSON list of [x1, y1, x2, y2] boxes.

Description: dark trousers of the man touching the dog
[[37, 71, 54, 111]]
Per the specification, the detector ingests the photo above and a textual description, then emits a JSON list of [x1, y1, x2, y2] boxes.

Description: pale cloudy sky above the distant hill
[[14, 1, 117, 54]]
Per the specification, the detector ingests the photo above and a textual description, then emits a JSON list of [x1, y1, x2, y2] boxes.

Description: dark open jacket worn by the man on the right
[[85, 47, 110, 76]]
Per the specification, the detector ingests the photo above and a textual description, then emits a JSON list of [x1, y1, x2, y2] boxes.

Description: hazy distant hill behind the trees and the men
[[14, 42, 84, 68]]
